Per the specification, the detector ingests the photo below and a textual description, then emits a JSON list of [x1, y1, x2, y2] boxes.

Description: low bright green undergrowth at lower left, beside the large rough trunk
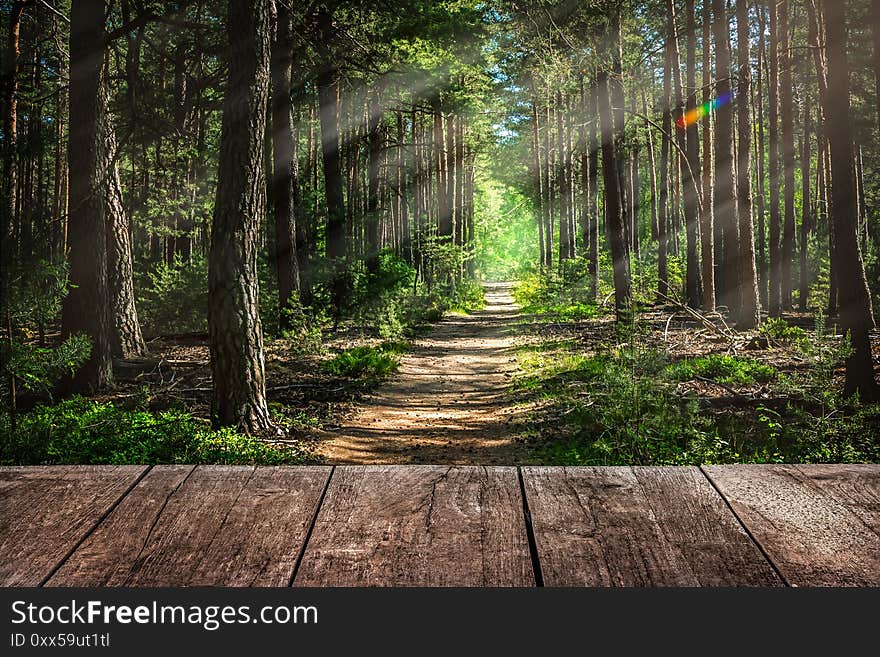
[[0, 397, 306, 465]]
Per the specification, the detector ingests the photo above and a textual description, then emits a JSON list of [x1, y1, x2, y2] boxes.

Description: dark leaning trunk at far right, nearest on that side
[[822, 0, 880, 402]]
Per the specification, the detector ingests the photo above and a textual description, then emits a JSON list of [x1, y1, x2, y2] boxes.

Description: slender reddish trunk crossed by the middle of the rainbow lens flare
[[700, 0, 716, 312]]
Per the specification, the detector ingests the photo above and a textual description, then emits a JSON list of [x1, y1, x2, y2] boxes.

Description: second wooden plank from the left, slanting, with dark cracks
[[48, 466, 331, 586]]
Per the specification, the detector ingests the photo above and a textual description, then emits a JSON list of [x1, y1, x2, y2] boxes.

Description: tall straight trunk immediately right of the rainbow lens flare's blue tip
[[725, 0, 760, 329]]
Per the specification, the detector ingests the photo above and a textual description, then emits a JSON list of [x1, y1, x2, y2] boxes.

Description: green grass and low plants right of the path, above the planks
[[514, 341, 880, 465]]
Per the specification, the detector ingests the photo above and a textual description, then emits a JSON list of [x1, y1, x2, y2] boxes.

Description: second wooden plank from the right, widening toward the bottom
[[523, 467, 781, 586]]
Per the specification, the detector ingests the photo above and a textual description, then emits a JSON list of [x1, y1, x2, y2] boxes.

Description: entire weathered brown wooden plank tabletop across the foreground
[[0, 465, 880, 587]]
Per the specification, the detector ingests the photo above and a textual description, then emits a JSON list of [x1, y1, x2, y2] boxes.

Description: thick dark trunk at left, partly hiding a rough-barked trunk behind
[[61, 0, 113, 391]]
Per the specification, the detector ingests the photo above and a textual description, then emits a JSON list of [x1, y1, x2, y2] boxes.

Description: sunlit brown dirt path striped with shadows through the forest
[[318, 283, 527, 465]]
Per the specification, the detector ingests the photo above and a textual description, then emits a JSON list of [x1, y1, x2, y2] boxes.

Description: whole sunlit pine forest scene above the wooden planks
[[0, 0, 880, 465]]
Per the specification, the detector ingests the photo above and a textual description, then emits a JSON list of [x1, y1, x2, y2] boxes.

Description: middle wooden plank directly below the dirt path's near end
[[294, 466, 535, 586]]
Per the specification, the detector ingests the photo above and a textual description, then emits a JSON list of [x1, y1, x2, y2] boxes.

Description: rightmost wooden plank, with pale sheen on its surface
[[704, 465, 880, 586]]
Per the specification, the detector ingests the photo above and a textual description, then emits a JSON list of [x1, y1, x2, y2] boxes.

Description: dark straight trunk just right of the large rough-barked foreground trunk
[[270, 3, 299, 328]]
